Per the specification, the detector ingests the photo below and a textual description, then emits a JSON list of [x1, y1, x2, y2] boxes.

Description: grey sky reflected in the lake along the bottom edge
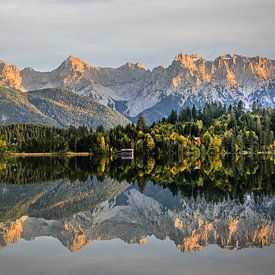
[[0, 237, 275, 275]]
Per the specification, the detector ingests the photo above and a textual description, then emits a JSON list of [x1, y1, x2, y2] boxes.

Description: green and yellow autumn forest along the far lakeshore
[[0, 101, 275, 157]]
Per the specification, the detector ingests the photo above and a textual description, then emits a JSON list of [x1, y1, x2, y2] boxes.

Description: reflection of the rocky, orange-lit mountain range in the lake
[[0, 184, 275, 252]]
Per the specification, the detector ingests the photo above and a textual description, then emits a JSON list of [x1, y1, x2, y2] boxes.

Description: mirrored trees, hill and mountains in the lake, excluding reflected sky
[[0, 156, 275, 252]]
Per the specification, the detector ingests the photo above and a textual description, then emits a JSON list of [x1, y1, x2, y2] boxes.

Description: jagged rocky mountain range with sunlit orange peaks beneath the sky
[[0, 54, 275, 121]]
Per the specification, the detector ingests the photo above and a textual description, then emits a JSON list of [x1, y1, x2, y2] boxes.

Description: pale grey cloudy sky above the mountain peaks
[[0, 0, 275, 71]]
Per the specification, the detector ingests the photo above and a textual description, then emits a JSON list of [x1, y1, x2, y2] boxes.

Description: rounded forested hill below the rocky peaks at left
[[0, 87, 129, 129]]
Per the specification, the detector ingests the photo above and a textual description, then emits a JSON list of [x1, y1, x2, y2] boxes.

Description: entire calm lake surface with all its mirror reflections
[[0, 156, 275, 275]]
